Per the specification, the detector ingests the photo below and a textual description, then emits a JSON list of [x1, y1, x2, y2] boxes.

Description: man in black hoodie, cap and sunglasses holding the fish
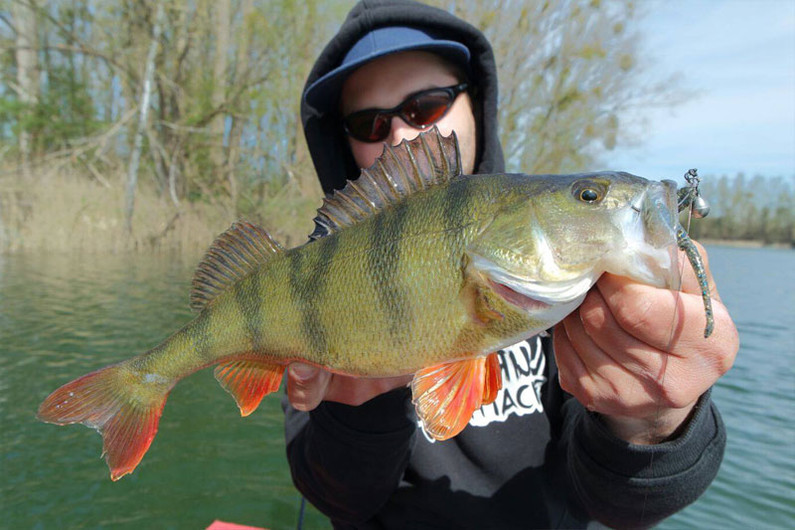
[[285, 1, 738, 528]]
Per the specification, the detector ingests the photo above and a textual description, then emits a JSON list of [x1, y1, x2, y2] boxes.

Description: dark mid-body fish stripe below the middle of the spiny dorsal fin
[[367, 201, 410, 337]]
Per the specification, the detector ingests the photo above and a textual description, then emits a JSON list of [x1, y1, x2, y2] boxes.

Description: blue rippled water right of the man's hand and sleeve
[[660, 247, 795, 529]]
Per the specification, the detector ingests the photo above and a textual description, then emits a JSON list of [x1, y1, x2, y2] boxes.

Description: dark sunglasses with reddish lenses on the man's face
[[342, 83, 467, 142]]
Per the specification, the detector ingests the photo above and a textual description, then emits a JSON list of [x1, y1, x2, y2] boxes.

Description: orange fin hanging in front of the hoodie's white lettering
[[411, 354, 501, 440]]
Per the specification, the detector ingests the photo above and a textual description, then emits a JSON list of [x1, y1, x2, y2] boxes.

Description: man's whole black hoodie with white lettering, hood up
[[283, 0, 726, 529]]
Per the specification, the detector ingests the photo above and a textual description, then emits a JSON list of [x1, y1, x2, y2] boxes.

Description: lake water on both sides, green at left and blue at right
[[0, 247, 795, 529]]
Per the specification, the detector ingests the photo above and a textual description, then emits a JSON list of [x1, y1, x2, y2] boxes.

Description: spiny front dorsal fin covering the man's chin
[[309, 126, 461, 240]]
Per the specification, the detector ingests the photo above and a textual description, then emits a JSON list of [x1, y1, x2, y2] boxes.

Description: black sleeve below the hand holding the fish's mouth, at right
[[563, 391, 726, 528]]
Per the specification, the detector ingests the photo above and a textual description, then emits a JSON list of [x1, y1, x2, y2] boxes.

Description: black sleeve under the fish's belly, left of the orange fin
[[282, 388, 417, 524]]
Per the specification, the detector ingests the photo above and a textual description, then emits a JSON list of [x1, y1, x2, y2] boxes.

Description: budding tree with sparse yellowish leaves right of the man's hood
[[438, 0, 684, 173]]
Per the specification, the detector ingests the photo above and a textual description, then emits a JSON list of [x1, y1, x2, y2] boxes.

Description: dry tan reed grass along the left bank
[[0, 162, 321, 256]]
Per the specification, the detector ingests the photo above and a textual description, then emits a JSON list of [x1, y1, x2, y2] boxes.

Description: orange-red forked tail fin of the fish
[[38, 361, 173, 481]]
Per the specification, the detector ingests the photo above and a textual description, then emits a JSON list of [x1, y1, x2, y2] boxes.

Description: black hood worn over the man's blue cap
[[301, 0, 505, 193]]
